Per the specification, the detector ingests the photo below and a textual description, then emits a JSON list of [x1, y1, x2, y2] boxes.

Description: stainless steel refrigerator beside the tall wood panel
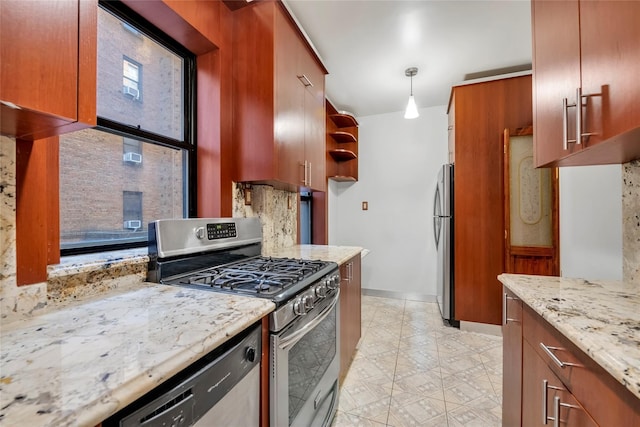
[[433, 164, 460, 326]]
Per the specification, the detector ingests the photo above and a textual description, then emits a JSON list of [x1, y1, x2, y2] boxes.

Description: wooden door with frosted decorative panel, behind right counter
[[504, 127, 560, 276]]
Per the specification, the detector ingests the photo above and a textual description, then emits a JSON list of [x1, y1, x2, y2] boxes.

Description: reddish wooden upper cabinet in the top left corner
[[0, 0, 98, 139]]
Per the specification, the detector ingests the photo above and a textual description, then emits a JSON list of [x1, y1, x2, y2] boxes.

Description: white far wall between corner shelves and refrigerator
[[328, 106, 447, 299]]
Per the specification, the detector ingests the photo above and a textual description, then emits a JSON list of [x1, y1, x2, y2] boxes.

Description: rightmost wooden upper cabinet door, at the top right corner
[[580, 0, 640, 147]]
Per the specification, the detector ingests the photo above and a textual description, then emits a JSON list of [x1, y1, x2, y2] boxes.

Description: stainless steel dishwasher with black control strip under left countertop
[[102, 324, 262, 427]]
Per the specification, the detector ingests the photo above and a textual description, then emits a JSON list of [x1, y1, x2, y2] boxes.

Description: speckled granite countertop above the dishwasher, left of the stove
[[0, 283, 275, 427]]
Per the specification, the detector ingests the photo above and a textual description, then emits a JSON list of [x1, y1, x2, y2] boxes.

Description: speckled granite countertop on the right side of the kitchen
[[498, 274, 640, 398]]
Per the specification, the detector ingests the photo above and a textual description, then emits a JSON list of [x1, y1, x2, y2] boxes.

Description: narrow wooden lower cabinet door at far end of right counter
[[502, 288, 522, 426]]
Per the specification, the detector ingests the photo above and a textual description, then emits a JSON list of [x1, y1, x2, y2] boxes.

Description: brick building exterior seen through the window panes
[[60, 10, 186, 247]]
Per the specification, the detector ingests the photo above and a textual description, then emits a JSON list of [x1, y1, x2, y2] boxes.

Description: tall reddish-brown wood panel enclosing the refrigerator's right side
[[448, 75, 533, 325]]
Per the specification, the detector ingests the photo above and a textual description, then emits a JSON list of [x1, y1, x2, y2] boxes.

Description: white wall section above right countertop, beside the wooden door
[[560, 165, 622, 280]]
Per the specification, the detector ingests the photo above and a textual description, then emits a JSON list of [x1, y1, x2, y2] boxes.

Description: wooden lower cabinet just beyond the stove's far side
[[340, 254, 362, 383]]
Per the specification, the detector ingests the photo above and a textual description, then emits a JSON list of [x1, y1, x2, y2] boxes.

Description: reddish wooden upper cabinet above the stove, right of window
[[234, 2, 326, 191]]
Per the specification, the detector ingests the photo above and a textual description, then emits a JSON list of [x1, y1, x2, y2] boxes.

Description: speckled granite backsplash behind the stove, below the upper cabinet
[[233, 182, 298, 251]]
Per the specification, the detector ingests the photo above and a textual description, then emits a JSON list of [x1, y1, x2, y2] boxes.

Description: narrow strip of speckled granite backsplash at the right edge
[[622, 160, 640, 285]]
